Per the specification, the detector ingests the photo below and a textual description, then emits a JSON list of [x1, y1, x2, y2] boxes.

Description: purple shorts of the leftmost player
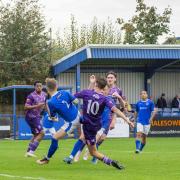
[[26, 118, 43, 135]]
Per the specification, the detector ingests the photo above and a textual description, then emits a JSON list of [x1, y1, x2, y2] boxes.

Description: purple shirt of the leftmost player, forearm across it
[[25, 91, 46, 119]]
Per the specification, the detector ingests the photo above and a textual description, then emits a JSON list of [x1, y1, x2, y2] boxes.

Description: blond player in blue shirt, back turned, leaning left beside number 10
[[37, 78, 80, 164]]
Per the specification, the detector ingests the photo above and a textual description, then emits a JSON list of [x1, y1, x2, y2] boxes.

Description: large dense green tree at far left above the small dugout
[[0, 0, 50, 86]]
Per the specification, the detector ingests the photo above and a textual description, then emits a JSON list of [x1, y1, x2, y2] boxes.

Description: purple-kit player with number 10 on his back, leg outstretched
[[65, 78, 134, 170]]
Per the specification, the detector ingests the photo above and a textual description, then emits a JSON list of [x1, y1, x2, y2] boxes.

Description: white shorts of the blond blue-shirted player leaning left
[[61, 112, 81, 134]]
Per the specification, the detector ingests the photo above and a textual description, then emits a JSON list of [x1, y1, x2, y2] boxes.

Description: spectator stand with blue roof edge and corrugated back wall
[[53, 45, 180, 135]]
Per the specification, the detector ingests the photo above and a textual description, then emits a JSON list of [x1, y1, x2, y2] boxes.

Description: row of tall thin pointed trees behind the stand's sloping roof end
[[52, 15, 121, 61]]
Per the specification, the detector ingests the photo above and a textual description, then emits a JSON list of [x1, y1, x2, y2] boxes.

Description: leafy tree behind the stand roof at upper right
[[117, 0, 172, 44]]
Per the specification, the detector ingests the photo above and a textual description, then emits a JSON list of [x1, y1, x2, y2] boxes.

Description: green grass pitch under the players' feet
[[0, 138, 180, 180]]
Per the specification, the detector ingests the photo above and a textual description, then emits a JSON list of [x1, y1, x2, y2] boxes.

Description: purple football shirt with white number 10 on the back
[[75, 90, 114, 127]]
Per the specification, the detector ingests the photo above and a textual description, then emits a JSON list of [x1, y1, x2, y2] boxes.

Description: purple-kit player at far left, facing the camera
[[24, 81, 46, 157]]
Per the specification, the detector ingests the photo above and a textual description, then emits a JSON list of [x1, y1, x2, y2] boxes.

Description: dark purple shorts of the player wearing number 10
[[83, 124, 101, 146]]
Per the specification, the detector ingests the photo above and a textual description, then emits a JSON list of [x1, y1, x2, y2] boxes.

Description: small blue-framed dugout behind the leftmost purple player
[[0, 85, 72, 139]]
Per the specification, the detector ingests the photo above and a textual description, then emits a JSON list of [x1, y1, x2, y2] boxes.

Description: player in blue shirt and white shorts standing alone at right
[[135, 91, 156, 153]]
